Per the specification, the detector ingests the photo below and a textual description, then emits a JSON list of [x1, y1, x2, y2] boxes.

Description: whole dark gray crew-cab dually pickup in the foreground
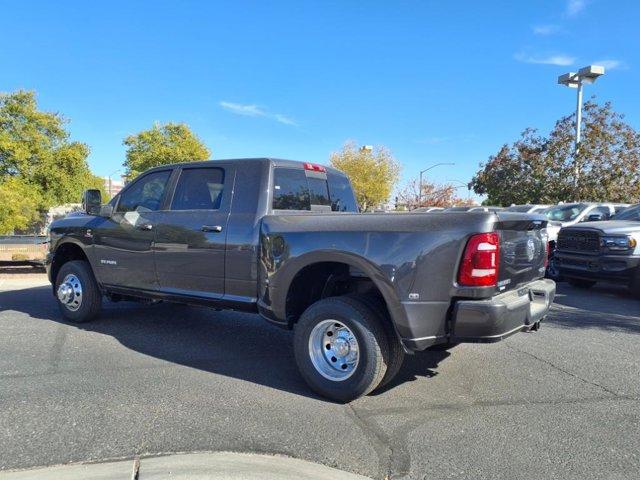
[[47, 158, 555, 401]]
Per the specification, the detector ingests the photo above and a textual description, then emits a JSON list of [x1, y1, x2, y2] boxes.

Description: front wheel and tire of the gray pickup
[[55, 260, 102, 323]]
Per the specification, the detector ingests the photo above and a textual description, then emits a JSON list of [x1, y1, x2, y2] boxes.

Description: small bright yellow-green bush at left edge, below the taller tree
[[0, 175, 42, 234]]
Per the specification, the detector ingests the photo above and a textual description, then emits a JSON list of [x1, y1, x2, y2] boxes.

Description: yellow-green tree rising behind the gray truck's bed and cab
[[330, 142, 400, 210]]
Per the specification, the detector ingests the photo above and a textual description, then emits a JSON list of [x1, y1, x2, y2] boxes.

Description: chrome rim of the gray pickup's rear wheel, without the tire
[[309, 320, 359, 382]]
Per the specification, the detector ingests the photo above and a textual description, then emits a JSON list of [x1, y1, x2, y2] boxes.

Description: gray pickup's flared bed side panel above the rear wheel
[[259, 212, 496, 326]]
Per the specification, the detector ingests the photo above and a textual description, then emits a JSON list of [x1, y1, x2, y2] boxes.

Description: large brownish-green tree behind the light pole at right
[[472, 100, 640, 205]]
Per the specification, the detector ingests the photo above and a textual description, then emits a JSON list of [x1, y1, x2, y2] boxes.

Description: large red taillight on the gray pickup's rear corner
[[458, 232, 500, 287]]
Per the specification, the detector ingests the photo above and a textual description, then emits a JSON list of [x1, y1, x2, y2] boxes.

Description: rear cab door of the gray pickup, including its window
[[154, 166, 235, 298]]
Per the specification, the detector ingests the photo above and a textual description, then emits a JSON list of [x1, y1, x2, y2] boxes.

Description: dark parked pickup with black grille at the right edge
[[555, 205, 640, 298]]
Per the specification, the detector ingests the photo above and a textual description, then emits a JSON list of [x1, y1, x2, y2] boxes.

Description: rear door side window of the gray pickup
[[171, 168, 224, 210]]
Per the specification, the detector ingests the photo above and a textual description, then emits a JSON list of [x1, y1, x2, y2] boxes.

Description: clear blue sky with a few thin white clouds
[[0, 0, 640, 193]]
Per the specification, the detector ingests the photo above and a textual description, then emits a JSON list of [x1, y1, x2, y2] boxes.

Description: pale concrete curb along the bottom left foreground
[[0, 452, 367, 480]]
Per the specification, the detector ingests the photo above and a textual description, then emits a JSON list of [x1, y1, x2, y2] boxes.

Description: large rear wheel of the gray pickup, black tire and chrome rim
[[293, 297, 389, 402]]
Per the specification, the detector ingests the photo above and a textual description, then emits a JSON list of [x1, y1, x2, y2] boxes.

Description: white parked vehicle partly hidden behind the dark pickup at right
[[545, 202, 628, 281]]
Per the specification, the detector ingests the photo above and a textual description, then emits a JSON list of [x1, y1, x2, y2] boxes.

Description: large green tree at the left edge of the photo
[[0, 91, 102, 230]]
